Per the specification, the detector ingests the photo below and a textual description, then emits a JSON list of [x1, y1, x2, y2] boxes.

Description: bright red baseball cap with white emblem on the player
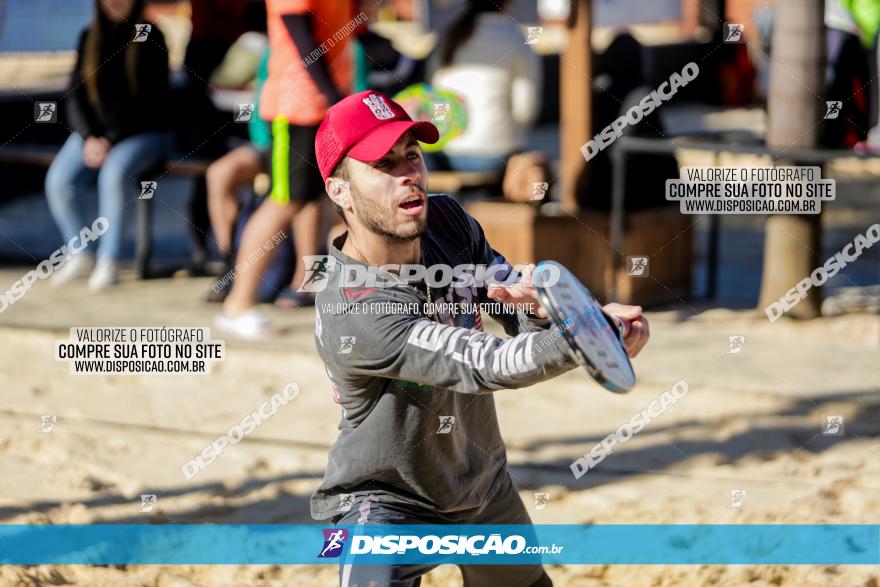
[[315, 90, 440, 179]]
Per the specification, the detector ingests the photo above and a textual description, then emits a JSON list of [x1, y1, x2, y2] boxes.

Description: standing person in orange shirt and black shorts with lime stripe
[[216, 0, 359, 337]]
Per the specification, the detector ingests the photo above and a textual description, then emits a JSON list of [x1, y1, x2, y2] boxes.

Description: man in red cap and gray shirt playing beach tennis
[[311, 91, 648, 587]]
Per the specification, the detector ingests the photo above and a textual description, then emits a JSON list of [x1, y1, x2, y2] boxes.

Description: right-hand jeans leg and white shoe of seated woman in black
[[89, 132, 170, 291]]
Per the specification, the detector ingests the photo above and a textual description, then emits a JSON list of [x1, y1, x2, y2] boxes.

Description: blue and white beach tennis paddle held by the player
[[532, 261, 636, 393]]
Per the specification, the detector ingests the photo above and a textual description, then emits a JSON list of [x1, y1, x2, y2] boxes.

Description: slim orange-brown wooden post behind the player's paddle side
[[559, 0, 593, 213]]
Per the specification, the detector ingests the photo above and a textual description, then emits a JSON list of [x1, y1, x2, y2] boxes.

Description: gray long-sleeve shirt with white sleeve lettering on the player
[[311, 195, 577, 521]]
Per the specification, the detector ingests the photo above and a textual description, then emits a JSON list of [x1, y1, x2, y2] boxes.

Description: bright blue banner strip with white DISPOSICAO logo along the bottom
[[0, 524, 880, 565]]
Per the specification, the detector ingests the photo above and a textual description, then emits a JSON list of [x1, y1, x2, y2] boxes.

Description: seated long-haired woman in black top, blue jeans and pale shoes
[[46, 0, 169, 291]]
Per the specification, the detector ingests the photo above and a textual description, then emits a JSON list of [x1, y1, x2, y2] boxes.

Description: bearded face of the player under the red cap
[[348, 133, 428, 241]]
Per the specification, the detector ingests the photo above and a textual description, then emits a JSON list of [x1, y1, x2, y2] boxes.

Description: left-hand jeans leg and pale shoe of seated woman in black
[[45, 133, 98, 287]]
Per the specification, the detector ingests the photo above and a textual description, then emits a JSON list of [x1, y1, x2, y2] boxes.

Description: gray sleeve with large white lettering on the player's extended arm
[[318, 288, 577, 394]]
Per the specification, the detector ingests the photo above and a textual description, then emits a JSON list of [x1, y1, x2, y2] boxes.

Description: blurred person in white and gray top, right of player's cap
[[428, 0, 542, 171]]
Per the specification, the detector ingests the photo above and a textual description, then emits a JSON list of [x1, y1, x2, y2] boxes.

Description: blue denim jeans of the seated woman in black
[[46, 132, 169, 260]]
